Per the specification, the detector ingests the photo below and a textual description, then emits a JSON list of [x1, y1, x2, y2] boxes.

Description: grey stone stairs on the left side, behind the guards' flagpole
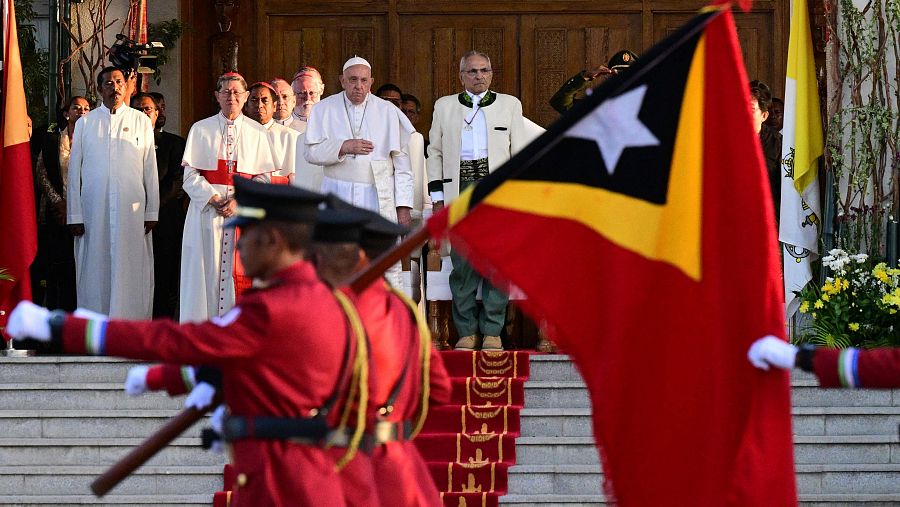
[[0, 357, 226, 507]]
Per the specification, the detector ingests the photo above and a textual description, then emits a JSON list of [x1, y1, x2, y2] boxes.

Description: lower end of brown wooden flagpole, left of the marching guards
[[91, 406, 212, 498]]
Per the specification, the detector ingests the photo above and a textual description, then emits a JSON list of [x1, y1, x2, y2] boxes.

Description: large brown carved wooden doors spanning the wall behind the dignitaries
[[184, 0, 788, 135]]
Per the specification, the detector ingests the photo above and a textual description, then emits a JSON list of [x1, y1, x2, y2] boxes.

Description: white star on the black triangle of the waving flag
[[566, 85, 659, 175]]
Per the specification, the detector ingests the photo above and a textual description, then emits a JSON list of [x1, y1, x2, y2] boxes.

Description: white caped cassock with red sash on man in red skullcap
[[179, 113, 276, 322]]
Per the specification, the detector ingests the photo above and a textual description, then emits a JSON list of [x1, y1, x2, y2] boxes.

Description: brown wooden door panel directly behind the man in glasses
[[396, 15, 520, 141]]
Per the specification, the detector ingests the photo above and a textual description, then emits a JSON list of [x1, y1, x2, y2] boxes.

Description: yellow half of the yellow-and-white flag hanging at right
[[787, 0, 824, 195]]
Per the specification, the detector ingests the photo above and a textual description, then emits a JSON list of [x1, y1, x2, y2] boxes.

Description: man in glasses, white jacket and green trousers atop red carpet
[[427, 51, 530, 350]]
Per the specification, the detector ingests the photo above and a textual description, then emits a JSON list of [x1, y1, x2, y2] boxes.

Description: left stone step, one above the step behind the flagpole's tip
[[0, 437, 227, 467]]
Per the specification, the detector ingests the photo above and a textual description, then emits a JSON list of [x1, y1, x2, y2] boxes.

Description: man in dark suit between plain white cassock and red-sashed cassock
[[131, 93, 187, 320]]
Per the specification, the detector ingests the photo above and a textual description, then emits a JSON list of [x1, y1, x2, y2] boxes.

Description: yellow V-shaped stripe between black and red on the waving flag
[[482, 35, 706, 280]]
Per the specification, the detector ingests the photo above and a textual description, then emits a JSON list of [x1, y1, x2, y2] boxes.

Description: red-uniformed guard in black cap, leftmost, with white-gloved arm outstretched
[[6, 179, 368, 507]]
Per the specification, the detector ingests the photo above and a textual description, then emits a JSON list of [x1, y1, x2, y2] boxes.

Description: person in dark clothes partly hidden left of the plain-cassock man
[[34, 95, 91, 311]]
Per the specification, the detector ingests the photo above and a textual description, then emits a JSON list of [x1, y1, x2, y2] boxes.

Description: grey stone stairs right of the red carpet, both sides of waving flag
[[500, 355, 900, 507]]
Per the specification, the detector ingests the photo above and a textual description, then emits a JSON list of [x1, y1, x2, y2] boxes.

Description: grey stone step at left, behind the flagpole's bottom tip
[[0, 465, 222, 500]]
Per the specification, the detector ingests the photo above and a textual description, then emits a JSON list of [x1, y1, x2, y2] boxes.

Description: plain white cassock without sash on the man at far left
[[67, 104, 159, 319]]
